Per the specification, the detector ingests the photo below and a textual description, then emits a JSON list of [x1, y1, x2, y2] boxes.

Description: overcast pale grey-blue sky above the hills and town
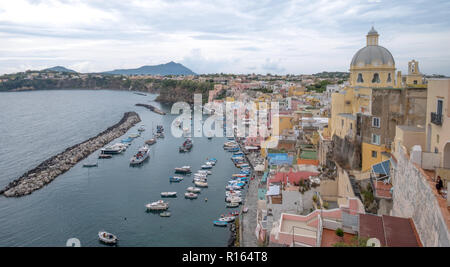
[[0, 0, 450, 75]]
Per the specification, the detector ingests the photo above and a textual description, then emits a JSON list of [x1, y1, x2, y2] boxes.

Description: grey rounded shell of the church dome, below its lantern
[[350, 45, 395, 67]]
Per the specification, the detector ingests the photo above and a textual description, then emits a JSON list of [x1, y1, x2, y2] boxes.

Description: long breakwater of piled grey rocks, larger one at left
[[0, 112, 141, 197]]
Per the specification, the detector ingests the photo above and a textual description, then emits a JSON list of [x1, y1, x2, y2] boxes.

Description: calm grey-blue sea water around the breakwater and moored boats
[[0, 90, 238, 246]]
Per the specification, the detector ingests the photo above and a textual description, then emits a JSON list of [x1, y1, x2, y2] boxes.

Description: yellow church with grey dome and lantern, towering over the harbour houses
[[329, 27, 426, 171]]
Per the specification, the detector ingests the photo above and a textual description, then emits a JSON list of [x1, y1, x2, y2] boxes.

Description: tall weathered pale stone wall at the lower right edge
[[391, 146, 450, 247]]
